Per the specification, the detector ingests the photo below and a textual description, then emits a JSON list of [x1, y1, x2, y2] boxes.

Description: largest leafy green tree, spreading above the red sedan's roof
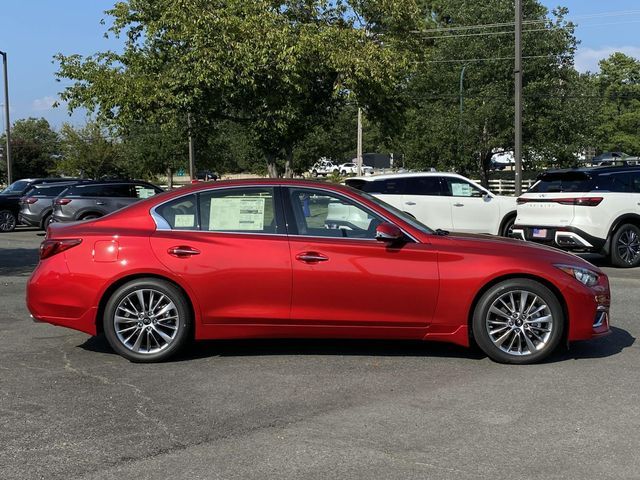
[[56, 0, 404, 175]]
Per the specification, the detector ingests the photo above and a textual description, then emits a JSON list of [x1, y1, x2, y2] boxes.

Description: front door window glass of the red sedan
[[289, 188, 384, 239]]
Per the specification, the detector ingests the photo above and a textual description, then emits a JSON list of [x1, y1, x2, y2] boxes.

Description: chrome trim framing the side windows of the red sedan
[[149, 184, 422, 243]]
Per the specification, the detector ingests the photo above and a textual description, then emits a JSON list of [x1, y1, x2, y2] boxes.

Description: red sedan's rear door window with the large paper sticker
[[199, 187, 278, 233]]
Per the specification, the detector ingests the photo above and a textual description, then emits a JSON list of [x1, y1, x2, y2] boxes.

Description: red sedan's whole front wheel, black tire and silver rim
[[472, 278, 565, 365]]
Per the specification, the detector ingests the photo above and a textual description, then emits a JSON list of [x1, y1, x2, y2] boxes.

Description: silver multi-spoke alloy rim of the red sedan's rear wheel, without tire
[[113, 288, 180, 354]]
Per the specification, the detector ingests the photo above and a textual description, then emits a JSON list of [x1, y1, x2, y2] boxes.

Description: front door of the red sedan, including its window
[[283, 187, 439, 330]]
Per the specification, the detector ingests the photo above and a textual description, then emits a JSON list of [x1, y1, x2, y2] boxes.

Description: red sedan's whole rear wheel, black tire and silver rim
[[102, 278, 193, 363]]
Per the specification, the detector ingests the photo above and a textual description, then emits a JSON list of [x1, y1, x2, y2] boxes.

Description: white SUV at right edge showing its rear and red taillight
[[513, 166, 640, 267]]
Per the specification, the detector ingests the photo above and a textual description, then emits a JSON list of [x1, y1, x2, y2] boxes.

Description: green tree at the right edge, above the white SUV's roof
[[596, 52, 640, 155]]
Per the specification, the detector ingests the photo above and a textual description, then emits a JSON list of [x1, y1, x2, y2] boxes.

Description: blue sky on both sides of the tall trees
[[0, 0, 640, 129]]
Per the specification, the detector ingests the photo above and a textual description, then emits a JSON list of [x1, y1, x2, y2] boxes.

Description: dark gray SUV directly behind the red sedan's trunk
[[52, 180, 163, 222]]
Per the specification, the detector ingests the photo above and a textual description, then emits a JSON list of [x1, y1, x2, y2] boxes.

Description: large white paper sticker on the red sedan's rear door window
[[209, 197, 265, 231]]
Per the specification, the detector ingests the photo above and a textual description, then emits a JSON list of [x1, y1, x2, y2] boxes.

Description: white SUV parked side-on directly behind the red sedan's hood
[[345, 172, 516, 236]]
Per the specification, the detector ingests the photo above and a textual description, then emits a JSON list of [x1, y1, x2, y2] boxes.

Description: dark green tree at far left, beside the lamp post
[[0, 118, 60, 178]]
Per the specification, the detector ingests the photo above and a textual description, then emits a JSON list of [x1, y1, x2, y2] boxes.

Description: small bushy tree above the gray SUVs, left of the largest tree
[[55, 122, 130, 179]]
